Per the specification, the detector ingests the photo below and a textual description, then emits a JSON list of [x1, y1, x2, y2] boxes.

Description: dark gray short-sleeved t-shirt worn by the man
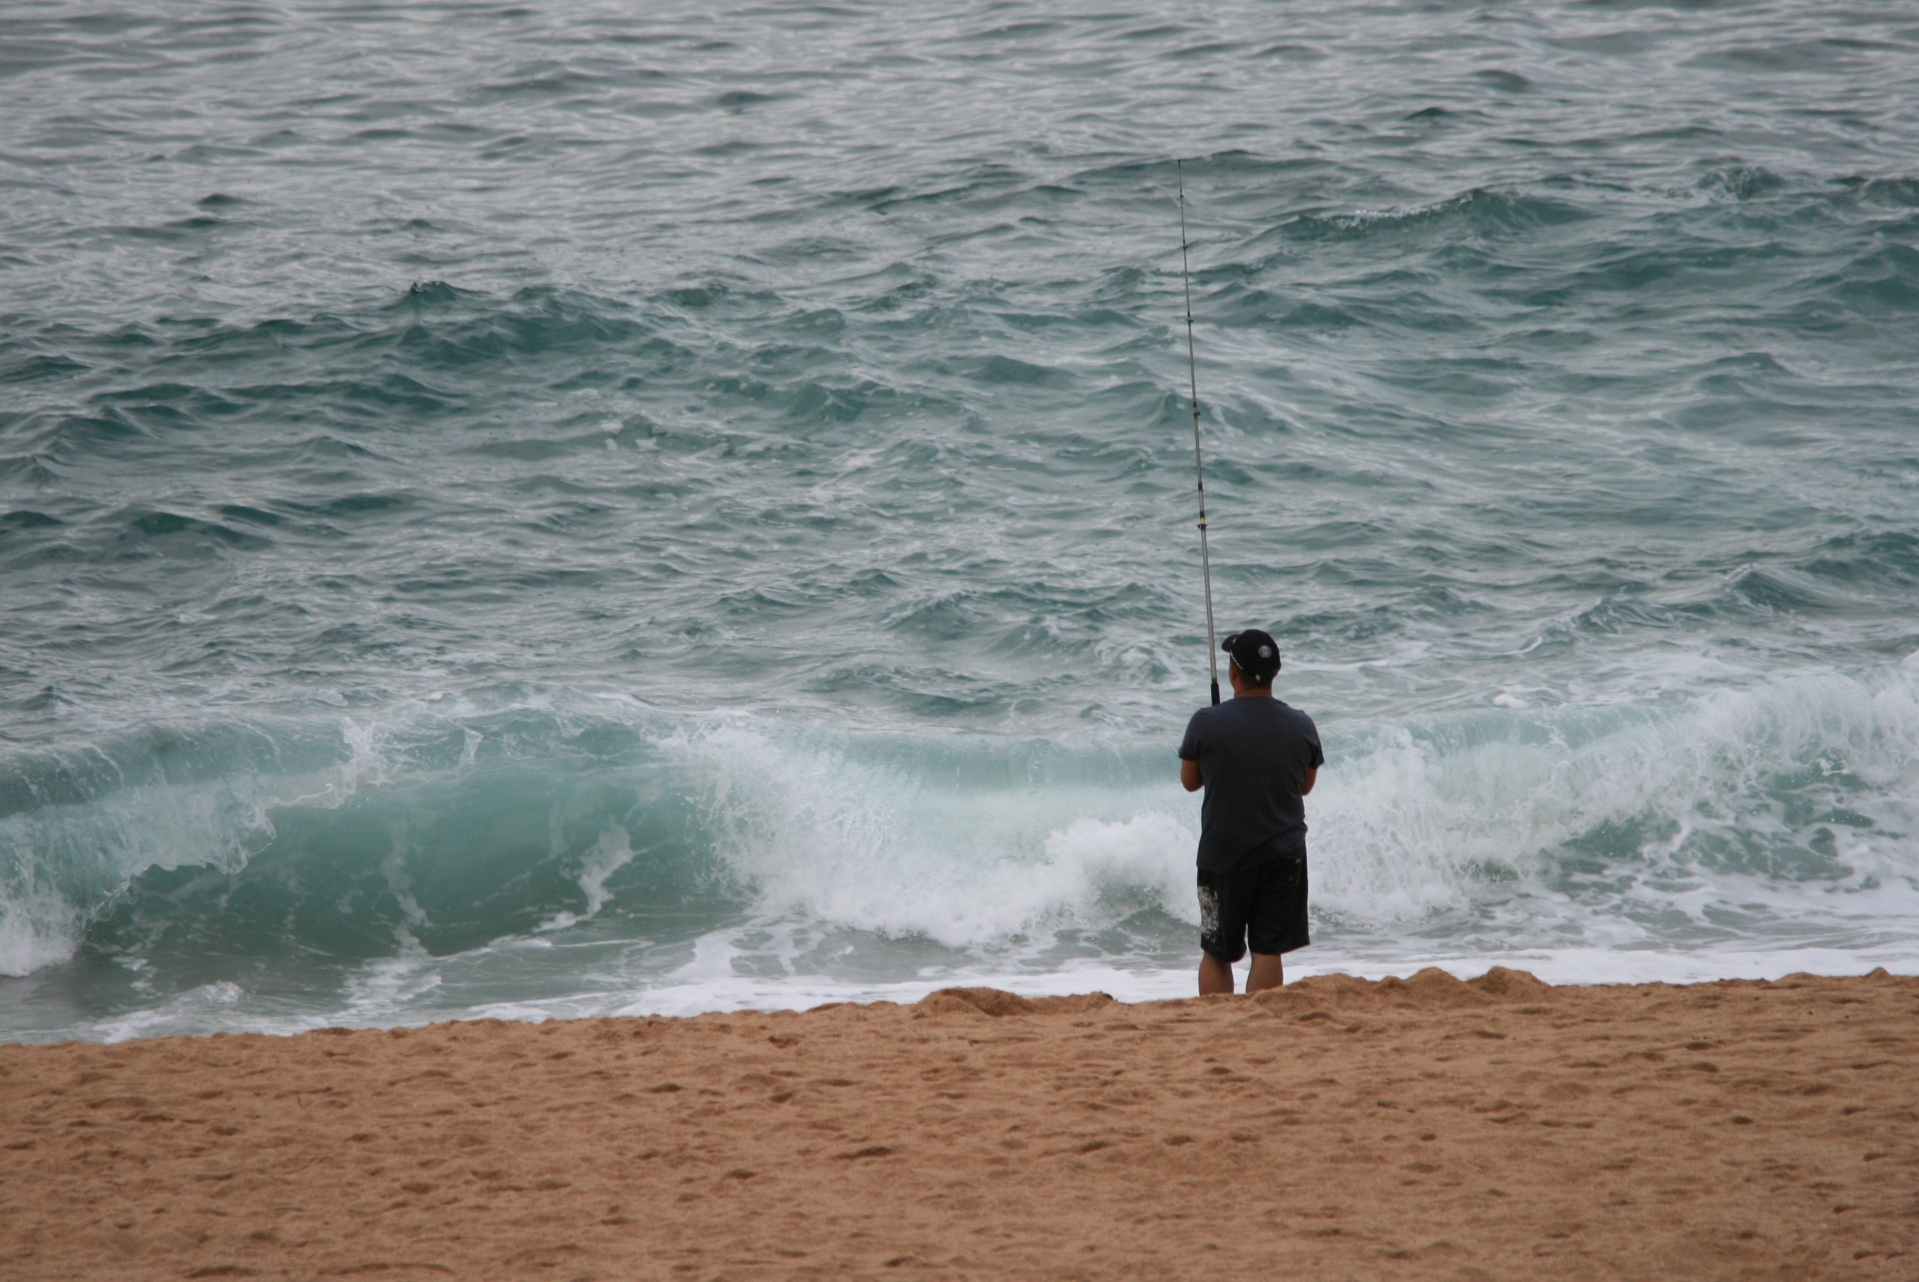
[[1180, 697, 1326, 873]]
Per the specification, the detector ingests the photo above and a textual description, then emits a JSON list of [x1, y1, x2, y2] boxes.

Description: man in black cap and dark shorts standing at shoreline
[[1180, 628, 1326, 996]]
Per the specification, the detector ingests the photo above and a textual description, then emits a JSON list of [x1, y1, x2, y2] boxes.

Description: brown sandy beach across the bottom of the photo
[[0, 971, 1919, 1282]]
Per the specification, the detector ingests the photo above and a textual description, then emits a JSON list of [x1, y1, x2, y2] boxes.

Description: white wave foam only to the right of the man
[[1309, 664, 1919, 927]]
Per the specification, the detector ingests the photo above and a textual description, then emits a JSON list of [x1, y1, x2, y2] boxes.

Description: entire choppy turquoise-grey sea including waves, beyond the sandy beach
[[0, 0, 1919, 1040]]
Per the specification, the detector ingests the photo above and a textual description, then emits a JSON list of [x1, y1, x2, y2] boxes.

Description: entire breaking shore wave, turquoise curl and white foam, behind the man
[[0, 656, 1919, 997]]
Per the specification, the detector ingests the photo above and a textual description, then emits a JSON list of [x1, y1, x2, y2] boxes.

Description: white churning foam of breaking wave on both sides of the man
[[652, 662, 1919, 971]]
